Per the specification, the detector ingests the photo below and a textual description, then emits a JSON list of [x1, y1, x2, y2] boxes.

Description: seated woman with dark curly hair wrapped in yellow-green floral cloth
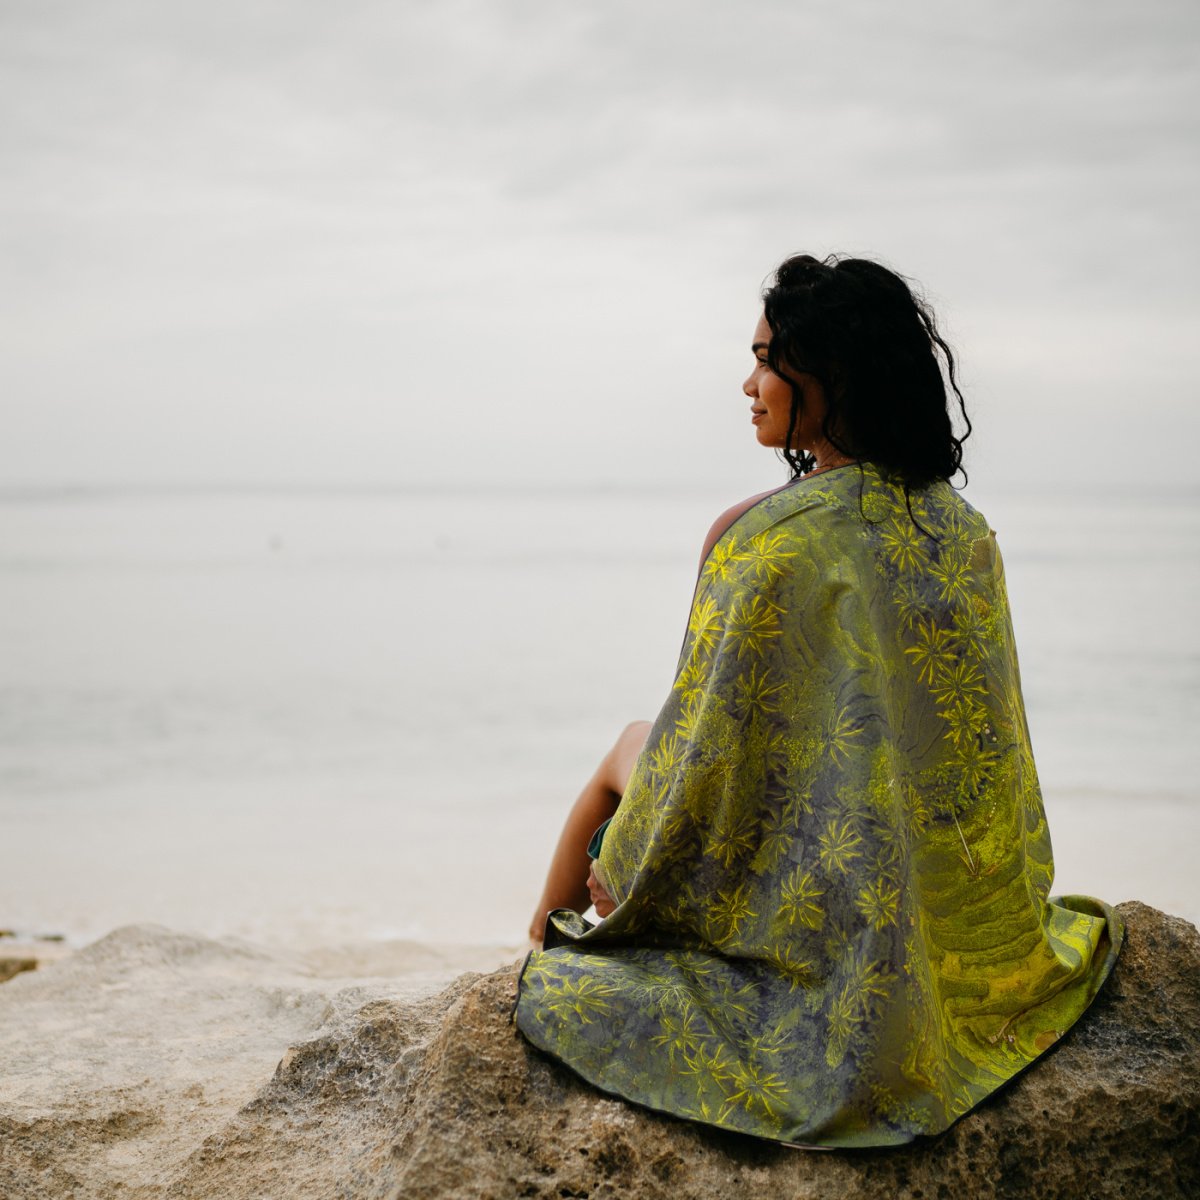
[[514, 256, 1124, 1148]]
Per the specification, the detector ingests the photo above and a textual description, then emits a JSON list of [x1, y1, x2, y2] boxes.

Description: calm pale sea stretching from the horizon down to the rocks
[[0, 481, 1200, 943]]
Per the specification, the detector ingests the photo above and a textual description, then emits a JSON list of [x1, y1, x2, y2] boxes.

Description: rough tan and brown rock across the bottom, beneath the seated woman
[[0, 901, 1200, 1200]]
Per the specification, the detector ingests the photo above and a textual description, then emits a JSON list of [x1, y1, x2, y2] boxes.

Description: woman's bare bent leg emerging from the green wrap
[[529, 721, 650, 946]]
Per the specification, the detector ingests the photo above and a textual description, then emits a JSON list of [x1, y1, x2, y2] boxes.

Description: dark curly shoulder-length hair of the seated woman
[[762, 254, 971, 516]]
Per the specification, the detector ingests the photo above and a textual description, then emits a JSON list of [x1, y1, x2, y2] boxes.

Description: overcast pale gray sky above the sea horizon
[[0, 0, 1200, 487]]
